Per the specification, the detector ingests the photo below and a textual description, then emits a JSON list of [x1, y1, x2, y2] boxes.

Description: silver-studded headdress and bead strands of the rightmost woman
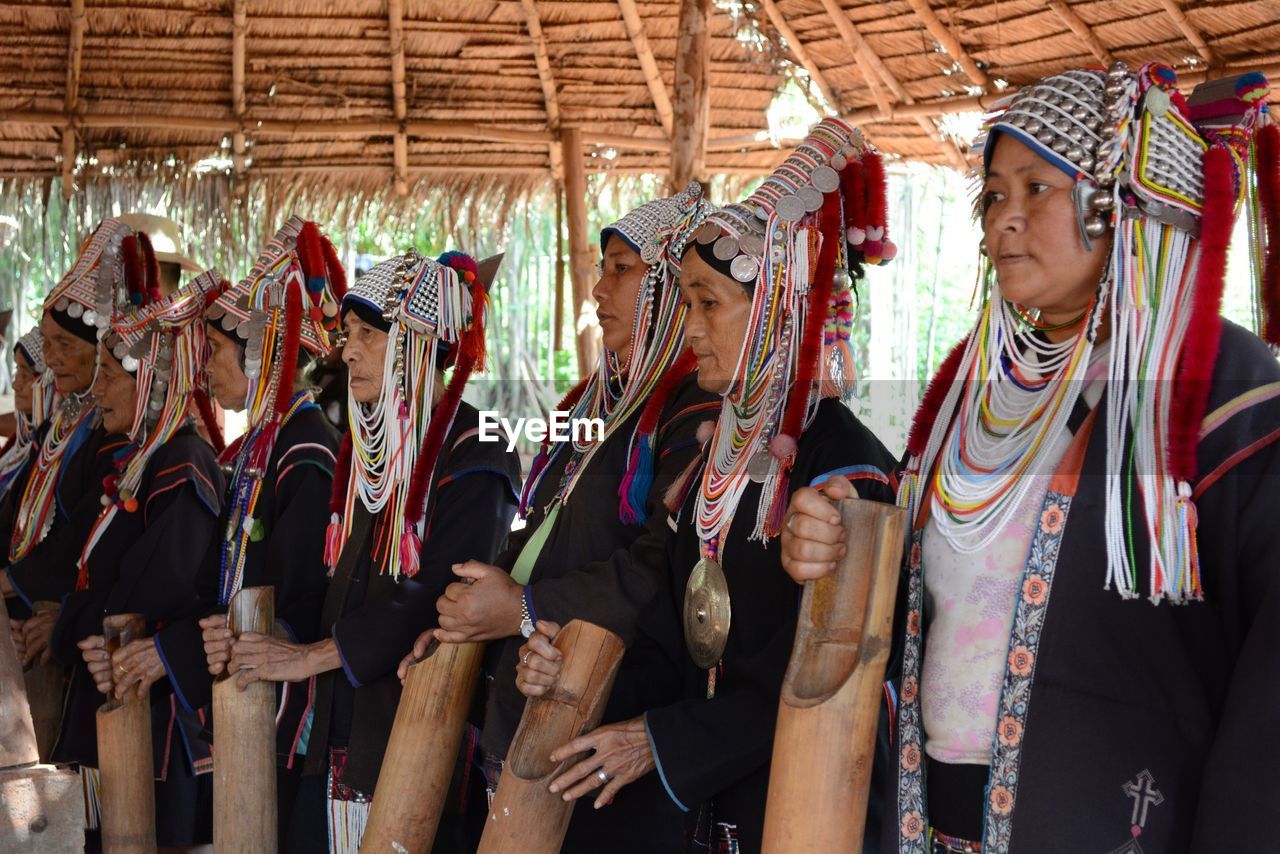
[[900, 63, 1276, 602]]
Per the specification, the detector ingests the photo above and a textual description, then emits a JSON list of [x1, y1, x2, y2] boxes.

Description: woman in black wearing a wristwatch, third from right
[[399, 183, 719, 851]]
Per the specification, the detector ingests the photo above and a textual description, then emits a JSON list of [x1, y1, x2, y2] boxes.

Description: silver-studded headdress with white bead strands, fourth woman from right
[[325, 251, 500, 577]]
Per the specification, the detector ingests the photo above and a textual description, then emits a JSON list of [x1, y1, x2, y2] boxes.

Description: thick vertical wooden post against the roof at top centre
[[671, 0, 712, 193]]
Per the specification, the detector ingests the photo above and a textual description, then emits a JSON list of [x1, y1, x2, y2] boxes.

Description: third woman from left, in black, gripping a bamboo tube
[[50, 265, 221, 848]]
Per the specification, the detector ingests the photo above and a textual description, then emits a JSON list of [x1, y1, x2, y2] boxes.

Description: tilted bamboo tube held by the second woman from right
[[479, 620, 623, 854]]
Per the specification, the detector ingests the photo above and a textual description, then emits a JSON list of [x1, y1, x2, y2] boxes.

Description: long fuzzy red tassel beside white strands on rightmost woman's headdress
[[1169, 146, 1235, 483]]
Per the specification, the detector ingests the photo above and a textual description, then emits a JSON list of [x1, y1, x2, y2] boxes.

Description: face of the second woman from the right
[[680, 251, 751, 394]]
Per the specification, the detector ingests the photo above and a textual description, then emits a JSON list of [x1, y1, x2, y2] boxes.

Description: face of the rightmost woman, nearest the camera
[[983, 134, 1111, 324]]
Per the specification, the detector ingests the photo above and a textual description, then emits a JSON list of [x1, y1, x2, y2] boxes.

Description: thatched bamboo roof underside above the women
[[0, 0, 1280, 193]]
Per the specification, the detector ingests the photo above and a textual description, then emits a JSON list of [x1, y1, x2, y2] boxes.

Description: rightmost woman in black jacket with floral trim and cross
[[783, 64, 1280, 854]]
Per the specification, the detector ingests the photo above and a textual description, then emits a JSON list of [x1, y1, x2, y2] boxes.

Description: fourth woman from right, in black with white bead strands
[[227, 252, 520, 854]]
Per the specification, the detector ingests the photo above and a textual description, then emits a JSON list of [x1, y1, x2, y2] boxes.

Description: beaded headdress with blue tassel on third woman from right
[[521, 181, 716, 525]]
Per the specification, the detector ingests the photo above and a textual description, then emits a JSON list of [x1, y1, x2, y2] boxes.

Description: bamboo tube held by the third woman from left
[[97, 613, 156, 854]]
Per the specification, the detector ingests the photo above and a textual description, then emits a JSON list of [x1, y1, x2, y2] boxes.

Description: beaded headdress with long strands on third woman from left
[[77, 271, 221, 589]]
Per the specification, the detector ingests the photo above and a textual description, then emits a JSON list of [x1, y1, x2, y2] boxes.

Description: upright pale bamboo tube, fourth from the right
[[214, 586, 276, 854]]
